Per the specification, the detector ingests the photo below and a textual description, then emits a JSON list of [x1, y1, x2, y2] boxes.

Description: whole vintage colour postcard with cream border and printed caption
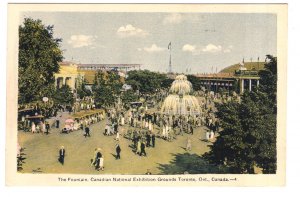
[[6, 4, 287, 187]]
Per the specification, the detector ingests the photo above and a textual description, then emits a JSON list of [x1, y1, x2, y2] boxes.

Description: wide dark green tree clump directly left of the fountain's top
[[126, 70, 172, 93]]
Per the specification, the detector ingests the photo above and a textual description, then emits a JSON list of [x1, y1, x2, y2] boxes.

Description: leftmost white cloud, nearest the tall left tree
[[68, 35, 97, 48]]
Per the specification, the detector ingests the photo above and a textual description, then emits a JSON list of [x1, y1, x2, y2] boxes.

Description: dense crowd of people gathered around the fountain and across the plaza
[[19, 86, 238, 171]]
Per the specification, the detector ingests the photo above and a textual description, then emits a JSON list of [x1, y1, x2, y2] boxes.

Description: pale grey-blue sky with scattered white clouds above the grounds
[[20, 12, 277, 74]]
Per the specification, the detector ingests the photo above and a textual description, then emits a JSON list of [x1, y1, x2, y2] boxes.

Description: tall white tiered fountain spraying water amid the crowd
[[161, 75, 200, 115]]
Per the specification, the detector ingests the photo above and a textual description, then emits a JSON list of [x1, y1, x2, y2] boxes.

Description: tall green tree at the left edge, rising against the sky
[[18, 18, 63, 103]]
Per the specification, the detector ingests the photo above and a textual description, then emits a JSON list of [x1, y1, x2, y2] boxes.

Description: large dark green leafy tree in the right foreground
[[205, 56, 277, 173]]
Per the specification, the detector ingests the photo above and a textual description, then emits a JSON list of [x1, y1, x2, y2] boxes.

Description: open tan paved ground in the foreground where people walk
[[18, 114, 209, 174]]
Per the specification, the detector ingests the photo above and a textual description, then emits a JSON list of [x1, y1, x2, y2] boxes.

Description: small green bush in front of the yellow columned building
[[53, 85, 74, 105]]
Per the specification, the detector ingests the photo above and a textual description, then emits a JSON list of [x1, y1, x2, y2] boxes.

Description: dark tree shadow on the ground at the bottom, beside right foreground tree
[[158, 153, 228, 174]]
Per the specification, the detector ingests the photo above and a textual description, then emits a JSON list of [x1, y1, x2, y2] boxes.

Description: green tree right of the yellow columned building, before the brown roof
[[93, 71, 123, 107]]
